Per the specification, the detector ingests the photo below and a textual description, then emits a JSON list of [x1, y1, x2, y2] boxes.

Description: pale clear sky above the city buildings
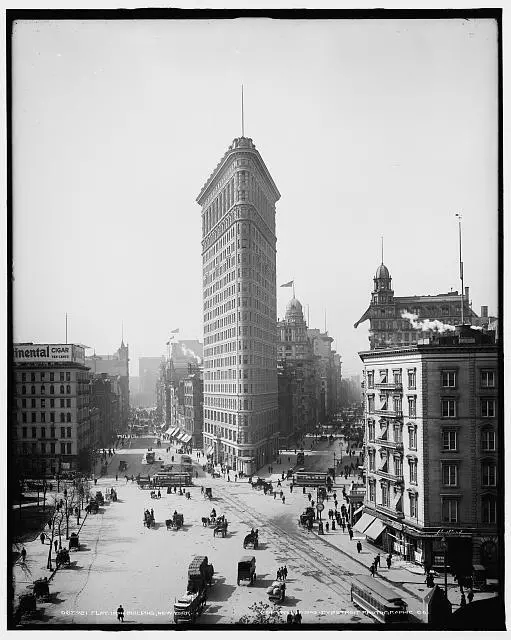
[[12, 19, 498, 375]]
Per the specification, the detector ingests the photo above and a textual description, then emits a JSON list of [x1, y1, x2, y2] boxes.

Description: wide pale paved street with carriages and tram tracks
[[15, 439, 474, 624]]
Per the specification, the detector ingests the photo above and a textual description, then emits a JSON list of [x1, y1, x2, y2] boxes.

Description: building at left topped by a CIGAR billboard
[[10, 343, 94, 477]]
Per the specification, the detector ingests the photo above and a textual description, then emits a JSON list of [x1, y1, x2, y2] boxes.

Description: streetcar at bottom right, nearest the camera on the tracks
[[351, 576, 408, 624]]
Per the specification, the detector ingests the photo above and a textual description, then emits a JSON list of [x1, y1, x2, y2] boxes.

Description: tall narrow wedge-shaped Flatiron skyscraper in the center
[[197, 137, 280, 474]]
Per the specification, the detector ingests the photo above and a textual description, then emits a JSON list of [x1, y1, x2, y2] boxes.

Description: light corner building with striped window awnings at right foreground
[[355, 327, 503, 576]]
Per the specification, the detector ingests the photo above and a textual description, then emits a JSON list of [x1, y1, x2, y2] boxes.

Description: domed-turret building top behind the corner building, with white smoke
[[354, 262, 480, 349]]
